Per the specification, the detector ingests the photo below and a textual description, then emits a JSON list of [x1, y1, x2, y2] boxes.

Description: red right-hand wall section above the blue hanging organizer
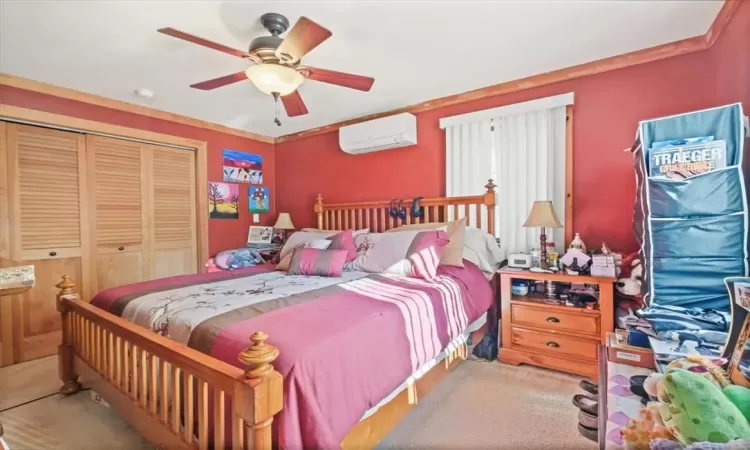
[[709, 1, 750, 109]]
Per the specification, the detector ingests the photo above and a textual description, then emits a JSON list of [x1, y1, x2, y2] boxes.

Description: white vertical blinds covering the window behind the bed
[[445, 106, 566, 253]]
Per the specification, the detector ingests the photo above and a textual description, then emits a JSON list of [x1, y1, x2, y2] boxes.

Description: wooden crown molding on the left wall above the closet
[[0, 73, 274, 144]]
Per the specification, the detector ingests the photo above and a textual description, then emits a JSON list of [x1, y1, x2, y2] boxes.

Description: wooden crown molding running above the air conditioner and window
[[276, 0, 750, 144]]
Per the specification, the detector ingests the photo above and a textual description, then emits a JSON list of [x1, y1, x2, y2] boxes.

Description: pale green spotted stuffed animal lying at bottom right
[[659, 368, 750, 445]]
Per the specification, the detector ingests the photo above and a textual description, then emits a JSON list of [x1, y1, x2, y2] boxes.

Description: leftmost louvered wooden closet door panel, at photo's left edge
[[0, 124, 90, 362]]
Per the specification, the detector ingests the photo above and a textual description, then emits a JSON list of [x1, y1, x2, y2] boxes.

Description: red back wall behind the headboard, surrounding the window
[[276, 52, 716, 251]]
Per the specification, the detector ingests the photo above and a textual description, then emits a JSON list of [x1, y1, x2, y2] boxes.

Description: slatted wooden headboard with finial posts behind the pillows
[[314, 180, 497, 235]]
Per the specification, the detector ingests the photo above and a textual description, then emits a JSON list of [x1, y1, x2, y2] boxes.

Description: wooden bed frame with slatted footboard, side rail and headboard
[[57, 180, 495, 450]]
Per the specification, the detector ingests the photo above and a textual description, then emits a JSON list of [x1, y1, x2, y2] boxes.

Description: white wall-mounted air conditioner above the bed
[[339, 113, 417, 155]]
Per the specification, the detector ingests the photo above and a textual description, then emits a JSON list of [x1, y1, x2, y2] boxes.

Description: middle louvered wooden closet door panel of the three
[[86, 136, 150, 291]]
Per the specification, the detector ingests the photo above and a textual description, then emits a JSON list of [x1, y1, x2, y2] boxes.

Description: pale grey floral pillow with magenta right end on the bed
[[346, 230, 448, 279]]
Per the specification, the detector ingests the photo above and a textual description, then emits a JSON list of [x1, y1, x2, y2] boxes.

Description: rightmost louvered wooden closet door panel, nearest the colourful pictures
[[149, 146, 198, 278]]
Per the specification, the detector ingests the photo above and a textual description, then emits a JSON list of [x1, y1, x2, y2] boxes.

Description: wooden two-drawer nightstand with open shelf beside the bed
[[498, 269, 615, 380]]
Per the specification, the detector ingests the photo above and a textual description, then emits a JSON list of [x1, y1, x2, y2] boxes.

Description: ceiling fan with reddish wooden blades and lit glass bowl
[[158, 13, 375, 126]]
